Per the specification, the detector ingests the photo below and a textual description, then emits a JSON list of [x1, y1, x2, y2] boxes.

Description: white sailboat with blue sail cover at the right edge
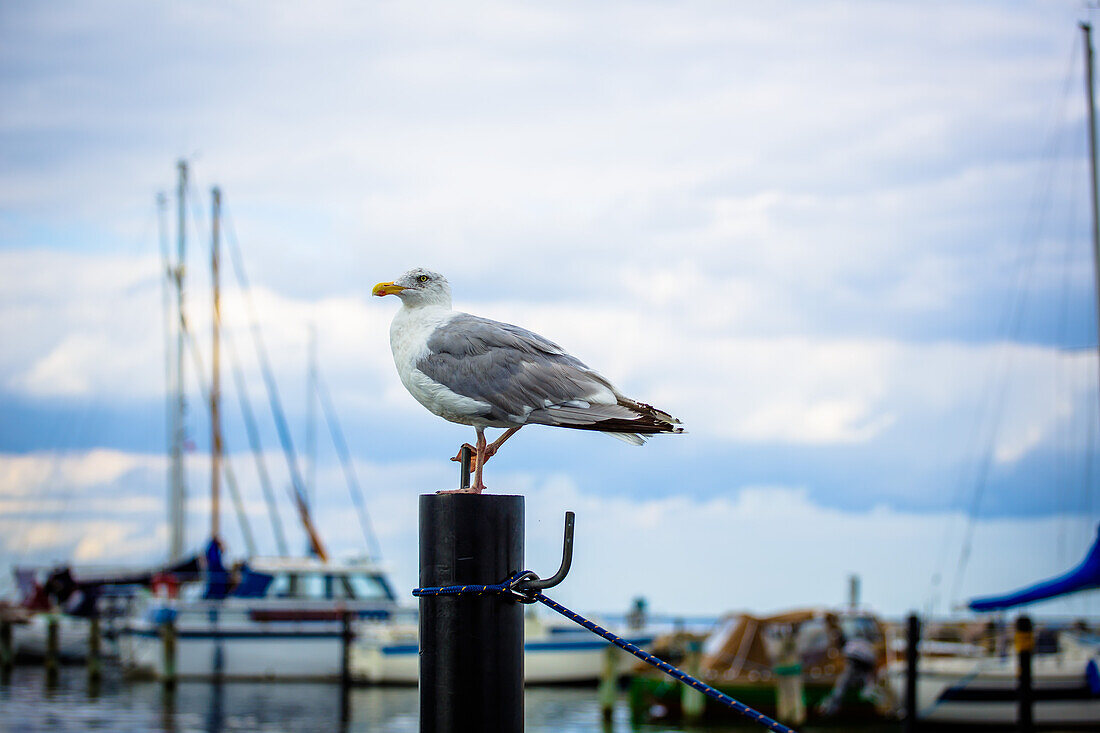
[[890, 23, 1100, 730]]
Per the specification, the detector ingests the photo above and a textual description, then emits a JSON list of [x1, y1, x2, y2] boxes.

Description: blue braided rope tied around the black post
[[413, 572, 796, 733]]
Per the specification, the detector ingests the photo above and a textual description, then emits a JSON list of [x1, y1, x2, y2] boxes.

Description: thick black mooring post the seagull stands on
[[420, 494, 524, 733]]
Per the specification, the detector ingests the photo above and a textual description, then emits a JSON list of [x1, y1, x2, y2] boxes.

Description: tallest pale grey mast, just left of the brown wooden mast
[[168, 161, 187, 561]]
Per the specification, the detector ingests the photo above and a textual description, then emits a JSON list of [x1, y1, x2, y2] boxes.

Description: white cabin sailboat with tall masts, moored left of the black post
[[119, 163, 404, 679]]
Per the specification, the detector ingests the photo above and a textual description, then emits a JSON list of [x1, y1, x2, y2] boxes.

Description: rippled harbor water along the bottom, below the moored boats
[[0, 667, 901, 733]]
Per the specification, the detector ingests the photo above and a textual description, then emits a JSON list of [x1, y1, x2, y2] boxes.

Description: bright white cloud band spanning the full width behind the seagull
[[0, 245, 1095, 462]]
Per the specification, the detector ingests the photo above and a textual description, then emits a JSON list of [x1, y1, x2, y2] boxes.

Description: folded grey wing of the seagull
[[417, 314, 653, 433]]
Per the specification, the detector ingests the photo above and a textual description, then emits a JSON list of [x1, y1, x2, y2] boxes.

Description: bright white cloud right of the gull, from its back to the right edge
[[482, 297, 1096, 456]]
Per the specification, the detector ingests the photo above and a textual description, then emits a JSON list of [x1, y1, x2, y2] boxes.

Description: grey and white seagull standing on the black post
[[371, 267, 683, 494]]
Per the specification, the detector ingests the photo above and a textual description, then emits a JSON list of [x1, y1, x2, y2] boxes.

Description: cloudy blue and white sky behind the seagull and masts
[[0, 1, 1100, 614]]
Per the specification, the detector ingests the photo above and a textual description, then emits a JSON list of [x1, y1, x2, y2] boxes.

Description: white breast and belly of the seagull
[[389, 306, 490, 425]]
